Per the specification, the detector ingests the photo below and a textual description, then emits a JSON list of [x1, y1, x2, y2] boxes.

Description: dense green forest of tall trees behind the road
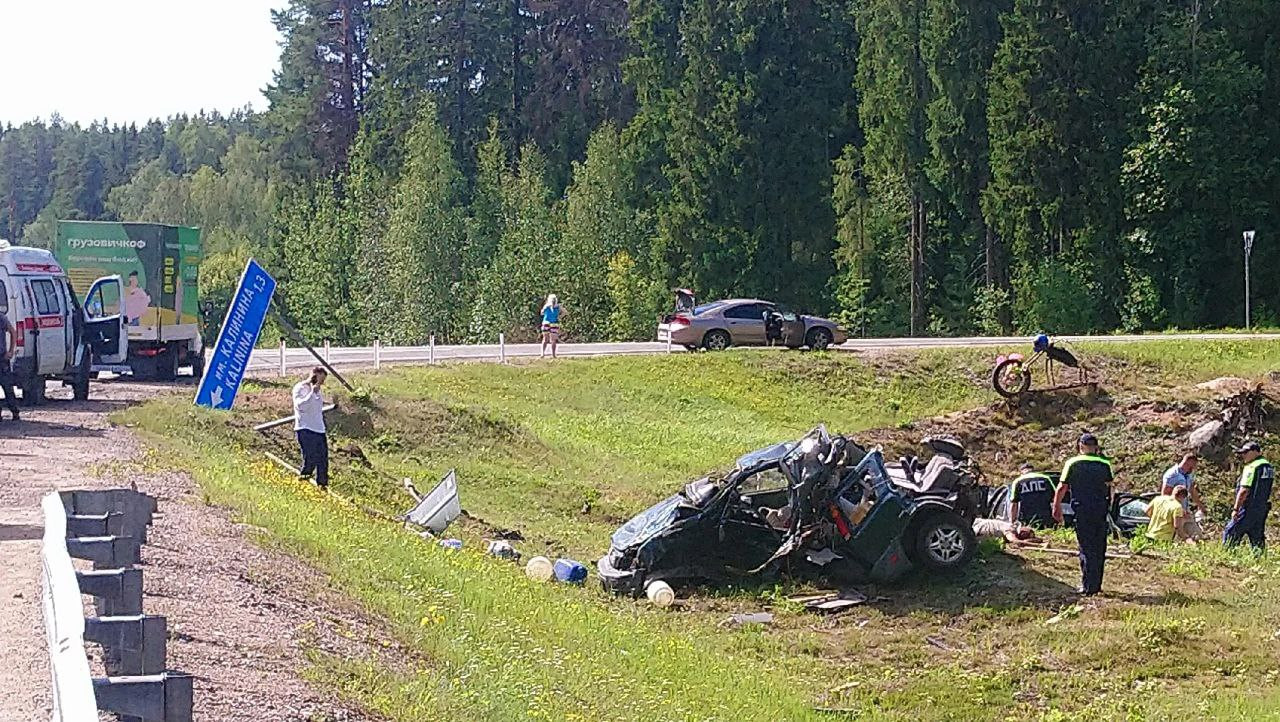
[[0, 0, 1280, 343]]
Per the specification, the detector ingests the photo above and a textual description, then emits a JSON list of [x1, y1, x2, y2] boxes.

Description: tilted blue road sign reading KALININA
[[196, 259, 275, 408]]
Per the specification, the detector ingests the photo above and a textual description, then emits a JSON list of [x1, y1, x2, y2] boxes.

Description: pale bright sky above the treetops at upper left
[[0, 0, 287, 124]]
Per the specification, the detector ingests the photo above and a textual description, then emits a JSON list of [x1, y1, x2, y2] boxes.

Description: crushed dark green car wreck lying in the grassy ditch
[[596, 426, 979, 595]]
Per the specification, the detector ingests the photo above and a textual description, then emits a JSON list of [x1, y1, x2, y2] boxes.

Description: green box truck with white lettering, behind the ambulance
[[54, 220, 205, 379]]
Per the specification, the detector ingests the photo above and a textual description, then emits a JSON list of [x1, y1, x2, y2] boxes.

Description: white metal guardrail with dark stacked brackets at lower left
[[41, 489, 193, 722]]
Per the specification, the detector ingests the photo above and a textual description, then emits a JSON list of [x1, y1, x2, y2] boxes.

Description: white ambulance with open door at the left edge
[[0, 241, 129, 406]]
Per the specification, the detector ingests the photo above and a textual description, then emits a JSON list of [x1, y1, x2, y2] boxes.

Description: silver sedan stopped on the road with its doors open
[[658, 297, 849, 351]]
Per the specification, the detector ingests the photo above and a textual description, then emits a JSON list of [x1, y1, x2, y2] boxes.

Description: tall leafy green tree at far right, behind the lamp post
[[1124, 8, 1267, 330]]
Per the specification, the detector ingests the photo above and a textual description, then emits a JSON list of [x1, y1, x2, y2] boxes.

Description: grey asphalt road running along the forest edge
[[241, 333, 1280, 374]]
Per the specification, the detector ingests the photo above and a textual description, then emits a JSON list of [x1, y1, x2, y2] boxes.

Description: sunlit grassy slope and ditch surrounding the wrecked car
[[122, 342, 1280, 719]]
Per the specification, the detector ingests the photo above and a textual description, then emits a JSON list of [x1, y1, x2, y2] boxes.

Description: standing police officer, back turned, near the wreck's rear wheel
[[1053, 433, 1115, 595]]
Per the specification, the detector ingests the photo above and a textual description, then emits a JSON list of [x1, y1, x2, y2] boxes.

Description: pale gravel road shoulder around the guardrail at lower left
[[0, 383, 394, 722]]
